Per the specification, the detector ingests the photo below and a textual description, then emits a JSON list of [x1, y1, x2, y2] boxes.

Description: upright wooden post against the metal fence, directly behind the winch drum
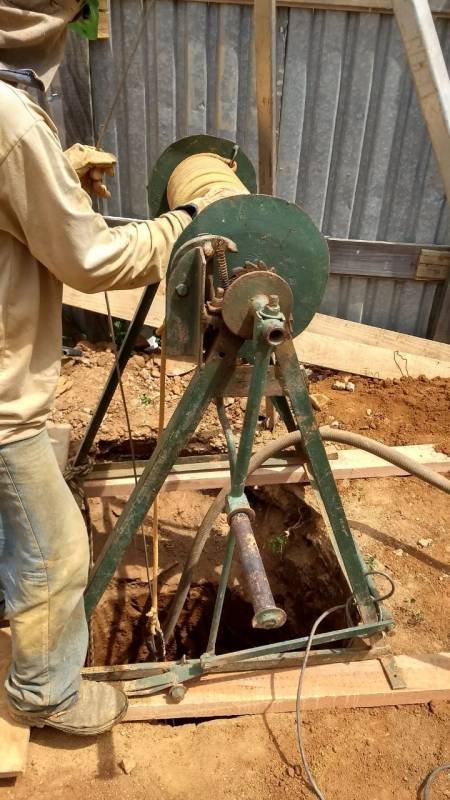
[[253, 0, 276, 195]]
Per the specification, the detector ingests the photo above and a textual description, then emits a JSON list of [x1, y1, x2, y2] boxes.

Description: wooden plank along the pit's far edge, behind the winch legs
[[83, 444, 450, 497]]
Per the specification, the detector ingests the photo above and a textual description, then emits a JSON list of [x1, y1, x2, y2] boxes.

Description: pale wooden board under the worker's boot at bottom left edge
[[0, 628, 30, 780]]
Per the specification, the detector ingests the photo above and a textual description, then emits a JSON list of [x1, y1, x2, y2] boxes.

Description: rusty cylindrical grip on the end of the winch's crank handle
[[230, 511, 286, 630]]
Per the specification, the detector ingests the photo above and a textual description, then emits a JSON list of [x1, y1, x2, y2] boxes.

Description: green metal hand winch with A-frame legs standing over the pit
[[75, 136, 399, 702]]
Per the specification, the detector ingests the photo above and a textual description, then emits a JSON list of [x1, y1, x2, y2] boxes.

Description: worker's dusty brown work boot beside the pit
[[8, 680, 128, 736]]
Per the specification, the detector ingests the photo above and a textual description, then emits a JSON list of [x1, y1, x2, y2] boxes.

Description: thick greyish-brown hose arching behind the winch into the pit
[[164, 426, 450, 641]]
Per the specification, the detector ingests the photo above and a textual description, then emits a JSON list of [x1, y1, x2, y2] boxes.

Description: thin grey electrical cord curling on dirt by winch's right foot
[[295, 570, 396, 800]]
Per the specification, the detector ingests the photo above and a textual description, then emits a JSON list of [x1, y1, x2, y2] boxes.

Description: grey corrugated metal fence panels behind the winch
[[81, 0, 450, 335]]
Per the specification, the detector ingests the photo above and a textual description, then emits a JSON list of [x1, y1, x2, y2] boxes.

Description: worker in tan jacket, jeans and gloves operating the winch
[[0, 0, 237, 735]]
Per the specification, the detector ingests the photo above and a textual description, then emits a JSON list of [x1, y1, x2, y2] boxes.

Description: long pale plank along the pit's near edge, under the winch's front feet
[[125, 653, 450, 721]]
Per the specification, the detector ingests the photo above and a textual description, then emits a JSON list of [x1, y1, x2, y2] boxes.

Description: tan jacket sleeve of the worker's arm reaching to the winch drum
[[0, 121, 191, 292]]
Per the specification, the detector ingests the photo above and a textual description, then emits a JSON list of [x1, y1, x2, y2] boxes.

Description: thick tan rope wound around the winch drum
[[167, 153, 249, 213]]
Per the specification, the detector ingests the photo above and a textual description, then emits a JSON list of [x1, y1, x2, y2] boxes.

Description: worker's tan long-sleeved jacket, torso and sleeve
[[0, 81, 190, 445]]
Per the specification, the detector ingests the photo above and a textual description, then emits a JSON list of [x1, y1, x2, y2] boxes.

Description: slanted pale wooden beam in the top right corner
[[392, 0, 450, 203]]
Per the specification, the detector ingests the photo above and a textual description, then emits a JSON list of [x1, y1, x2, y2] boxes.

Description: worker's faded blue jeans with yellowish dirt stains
[[0, 430, 89, 714]]
